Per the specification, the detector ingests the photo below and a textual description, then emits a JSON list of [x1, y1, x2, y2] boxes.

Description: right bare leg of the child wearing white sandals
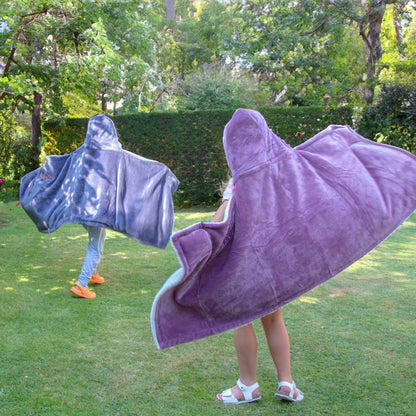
[[261, 309, 298, 398]]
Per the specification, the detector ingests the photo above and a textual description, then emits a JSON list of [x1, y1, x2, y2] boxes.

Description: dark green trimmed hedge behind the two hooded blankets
[[44, 107, 352, 207]]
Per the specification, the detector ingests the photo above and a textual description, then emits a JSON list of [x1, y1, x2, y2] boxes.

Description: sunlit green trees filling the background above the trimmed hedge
[[0, 0, 416, 177]]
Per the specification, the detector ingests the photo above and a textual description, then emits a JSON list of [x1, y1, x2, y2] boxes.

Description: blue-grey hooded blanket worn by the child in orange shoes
[[20, 114, 179, 248]]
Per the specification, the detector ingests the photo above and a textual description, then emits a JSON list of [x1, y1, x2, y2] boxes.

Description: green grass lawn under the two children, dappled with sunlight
[[0, 202, 416, 416]]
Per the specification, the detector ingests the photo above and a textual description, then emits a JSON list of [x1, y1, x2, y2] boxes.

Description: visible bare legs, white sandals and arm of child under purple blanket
[[213, 179, 303, 404]]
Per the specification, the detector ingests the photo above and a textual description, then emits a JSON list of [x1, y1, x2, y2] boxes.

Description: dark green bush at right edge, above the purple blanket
[[359, 84, 416, 154]]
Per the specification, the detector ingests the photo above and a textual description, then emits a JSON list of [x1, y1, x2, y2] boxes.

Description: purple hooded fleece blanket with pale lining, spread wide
[[151, 109, 416, 348]]
